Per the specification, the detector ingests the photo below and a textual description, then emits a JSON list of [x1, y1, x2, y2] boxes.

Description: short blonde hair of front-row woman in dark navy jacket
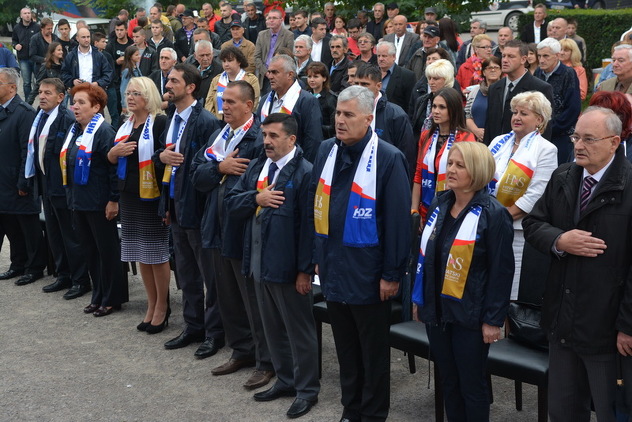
[[448, 142, 496, 192]]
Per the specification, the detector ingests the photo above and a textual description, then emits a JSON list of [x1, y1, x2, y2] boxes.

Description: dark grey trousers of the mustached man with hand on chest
[[255, 282, 320, 400]]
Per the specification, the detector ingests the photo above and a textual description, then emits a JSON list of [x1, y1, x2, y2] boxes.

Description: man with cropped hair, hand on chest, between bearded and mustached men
[[191, 81, 274, 389]]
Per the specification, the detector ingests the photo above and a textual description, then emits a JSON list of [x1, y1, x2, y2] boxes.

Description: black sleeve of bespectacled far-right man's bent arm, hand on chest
[[522, 167, 564, 255]]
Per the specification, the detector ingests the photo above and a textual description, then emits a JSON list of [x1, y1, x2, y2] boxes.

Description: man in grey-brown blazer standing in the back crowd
[[255, 9, 294, 94]]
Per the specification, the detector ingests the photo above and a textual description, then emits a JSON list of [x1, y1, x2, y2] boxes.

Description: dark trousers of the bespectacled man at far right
[[549, 343, 616, 422]]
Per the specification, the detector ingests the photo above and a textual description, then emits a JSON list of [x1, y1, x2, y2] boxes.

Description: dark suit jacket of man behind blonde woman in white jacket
[[483, 71, 555, 145]]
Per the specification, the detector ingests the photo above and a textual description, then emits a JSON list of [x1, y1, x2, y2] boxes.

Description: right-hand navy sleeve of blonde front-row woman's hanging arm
[[482, 205, 515, 327]]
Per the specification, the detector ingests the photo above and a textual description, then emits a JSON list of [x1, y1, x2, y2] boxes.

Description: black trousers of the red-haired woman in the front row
[[73, 210, 129, 306]]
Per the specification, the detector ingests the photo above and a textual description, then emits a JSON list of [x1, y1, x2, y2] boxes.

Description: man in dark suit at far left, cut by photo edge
[[0, 67, 46, 286]]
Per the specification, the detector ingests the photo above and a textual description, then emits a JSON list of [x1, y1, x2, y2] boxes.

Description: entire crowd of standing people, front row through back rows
[[0, 2, 632, 421]]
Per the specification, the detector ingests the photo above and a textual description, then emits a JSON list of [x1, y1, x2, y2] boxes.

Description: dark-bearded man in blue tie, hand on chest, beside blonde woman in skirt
[[152, 63, 224, 353]]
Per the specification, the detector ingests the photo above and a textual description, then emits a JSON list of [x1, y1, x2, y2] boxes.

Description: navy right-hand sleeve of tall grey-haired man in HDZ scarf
[[377, 153, 411, 282]]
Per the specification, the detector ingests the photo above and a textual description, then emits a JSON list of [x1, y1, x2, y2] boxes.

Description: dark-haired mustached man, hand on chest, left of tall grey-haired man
[[227, 113, 320, 418]]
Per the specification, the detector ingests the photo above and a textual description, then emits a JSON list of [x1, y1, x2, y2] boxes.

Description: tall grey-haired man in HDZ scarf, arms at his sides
[[310, 86, 411, 421]]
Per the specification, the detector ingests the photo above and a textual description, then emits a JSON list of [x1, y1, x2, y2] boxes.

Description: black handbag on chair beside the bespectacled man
[[507, 302, 549, 350]]
